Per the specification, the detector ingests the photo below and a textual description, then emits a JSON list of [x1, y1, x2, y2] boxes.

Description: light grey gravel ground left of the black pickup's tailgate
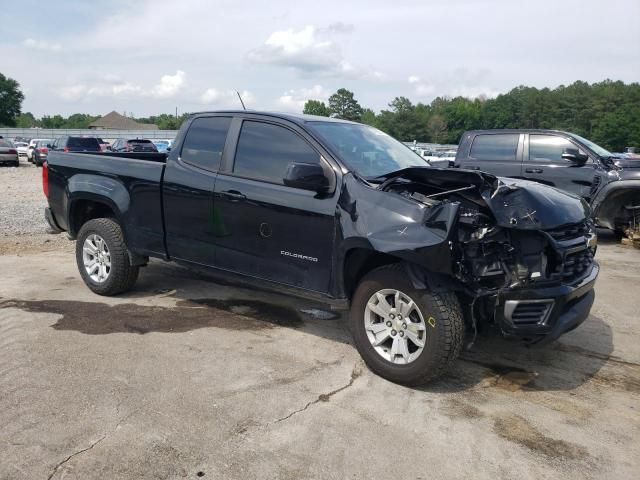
[[0, 159, 72, 254]]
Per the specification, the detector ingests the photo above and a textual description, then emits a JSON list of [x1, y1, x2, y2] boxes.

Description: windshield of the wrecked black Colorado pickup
[[308, 122, 429, 178]]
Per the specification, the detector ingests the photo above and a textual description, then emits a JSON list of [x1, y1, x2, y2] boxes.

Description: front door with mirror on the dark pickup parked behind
[[522, 133, 595, 197]]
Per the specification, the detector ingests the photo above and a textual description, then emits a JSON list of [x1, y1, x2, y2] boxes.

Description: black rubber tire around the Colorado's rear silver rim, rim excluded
[[76, 218, 139, 296]]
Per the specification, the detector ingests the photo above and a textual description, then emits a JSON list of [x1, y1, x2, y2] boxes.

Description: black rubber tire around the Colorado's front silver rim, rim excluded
[[349, 264, 464, 386]]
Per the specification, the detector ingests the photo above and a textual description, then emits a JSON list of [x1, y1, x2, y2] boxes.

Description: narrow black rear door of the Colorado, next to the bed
[[162, 116, 231, 265]]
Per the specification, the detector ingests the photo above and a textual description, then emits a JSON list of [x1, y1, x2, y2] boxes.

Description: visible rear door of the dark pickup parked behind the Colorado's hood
[[459, 133, 524, 177]]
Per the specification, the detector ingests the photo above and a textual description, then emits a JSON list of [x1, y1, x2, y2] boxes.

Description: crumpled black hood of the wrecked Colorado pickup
[[376, 167, 590, 230]]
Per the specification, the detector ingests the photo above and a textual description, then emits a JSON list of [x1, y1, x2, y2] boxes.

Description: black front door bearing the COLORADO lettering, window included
[[215, 119, 337, 292]]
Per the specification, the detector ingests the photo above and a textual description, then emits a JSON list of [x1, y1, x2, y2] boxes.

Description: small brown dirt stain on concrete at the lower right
[[493, 415, 589, 461]]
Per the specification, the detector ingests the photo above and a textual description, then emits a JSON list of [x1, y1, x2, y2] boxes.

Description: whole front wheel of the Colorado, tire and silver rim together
[[350, 265, 464, 385]]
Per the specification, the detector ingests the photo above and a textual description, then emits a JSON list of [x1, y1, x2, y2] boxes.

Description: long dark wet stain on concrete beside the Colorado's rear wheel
[[0, 299, 302, 335]]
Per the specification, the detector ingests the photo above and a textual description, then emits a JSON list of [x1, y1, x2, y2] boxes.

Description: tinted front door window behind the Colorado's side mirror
[[233, 121, 320, 184]]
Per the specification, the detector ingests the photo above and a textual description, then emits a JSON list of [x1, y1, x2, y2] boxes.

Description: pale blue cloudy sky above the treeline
[[0, 0, 640, 116]]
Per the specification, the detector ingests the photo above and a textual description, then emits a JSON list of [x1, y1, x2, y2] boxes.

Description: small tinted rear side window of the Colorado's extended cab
[[180, 117, 231, 172]]
